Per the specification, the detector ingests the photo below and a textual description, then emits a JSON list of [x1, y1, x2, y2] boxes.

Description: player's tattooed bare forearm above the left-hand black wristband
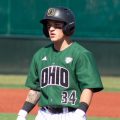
[[26, 89, 40, 104]]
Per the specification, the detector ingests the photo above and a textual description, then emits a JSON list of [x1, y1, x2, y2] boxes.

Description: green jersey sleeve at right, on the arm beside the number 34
[[76, 51, 103, 92]]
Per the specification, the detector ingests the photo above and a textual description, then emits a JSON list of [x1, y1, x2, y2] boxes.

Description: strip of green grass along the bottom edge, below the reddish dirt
[[0, 113, 120, 120]]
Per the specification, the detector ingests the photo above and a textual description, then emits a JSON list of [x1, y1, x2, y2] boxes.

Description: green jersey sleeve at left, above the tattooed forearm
[[25, 55, 40, 91]]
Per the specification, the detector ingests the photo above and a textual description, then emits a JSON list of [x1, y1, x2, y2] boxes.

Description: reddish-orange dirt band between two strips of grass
[[0, 89, 120, 118]]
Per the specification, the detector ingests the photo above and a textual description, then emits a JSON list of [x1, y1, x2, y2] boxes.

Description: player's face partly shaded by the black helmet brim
[[47, 20, 65, 42]]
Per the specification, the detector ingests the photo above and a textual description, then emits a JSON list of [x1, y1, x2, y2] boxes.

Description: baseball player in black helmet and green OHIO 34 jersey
[[17, 7, 103, 120]]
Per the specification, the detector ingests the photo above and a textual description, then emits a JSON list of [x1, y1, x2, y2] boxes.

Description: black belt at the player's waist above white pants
[[41, 106, 76, 114]]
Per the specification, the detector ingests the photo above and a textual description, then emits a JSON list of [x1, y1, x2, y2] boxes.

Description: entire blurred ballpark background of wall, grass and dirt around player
[[0, 0, 120, 120]]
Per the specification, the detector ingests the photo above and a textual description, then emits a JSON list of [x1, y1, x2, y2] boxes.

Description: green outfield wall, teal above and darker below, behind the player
[[0, 0, 120, 76]]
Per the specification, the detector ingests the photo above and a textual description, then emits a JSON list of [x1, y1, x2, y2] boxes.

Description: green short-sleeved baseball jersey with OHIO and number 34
[[25, 42, 103, 108]]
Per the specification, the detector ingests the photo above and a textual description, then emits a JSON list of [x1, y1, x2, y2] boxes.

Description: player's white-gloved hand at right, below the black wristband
[[74, 109, 87, 120]]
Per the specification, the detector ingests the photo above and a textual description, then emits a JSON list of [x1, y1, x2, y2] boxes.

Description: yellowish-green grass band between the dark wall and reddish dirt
[[0, 75, 120, 92]]
